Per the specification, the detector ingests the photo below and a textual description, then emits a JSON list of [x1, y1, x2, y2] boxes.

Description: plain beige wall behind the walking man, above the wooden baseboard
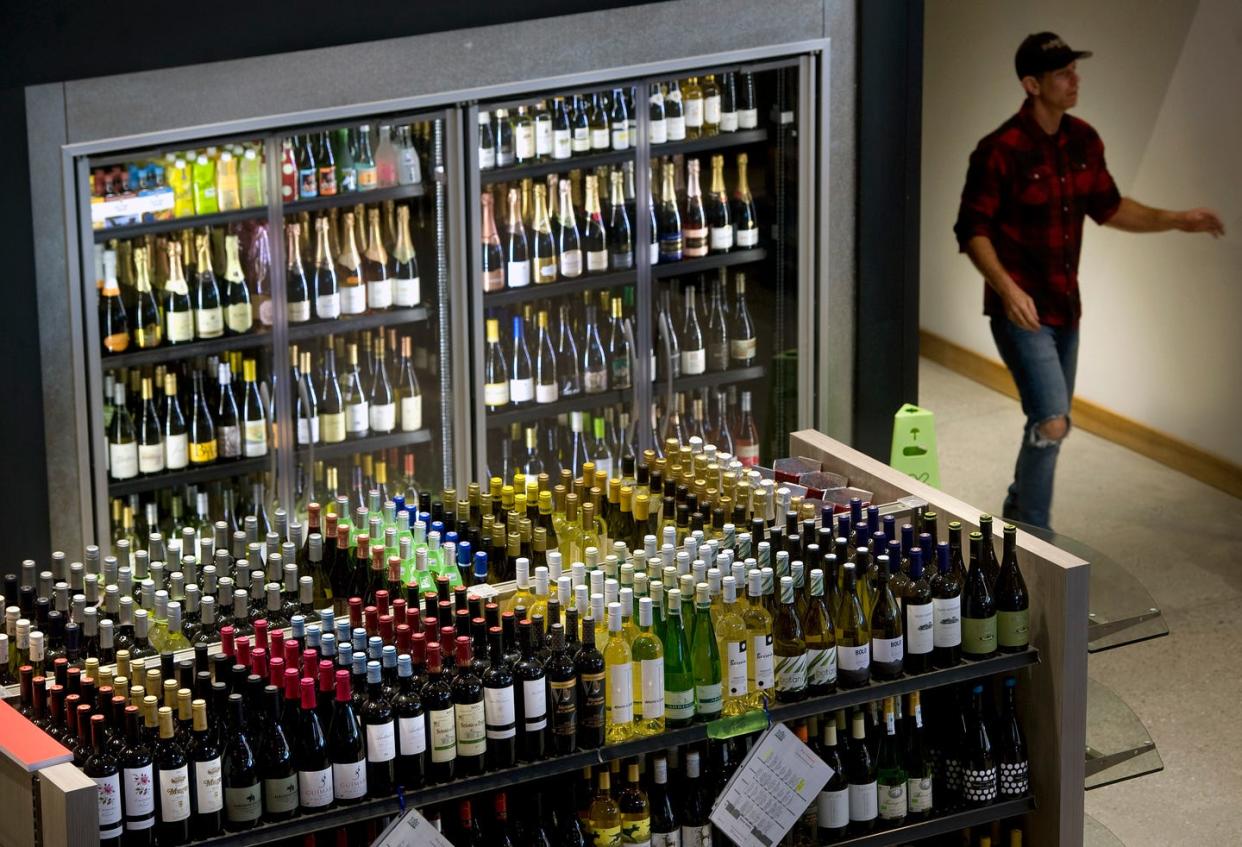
[[920, 0, 1242, 463]]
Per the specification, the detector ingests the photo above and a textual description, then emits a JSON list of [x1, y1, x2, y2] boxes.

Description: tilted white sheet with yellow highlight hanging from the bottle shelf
[[712, 724, 832, 847]]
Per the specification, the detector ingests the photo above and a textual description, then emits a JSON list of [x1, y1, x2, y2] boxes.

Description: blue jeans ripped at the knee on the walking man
[[991, 315, 1078, 529]]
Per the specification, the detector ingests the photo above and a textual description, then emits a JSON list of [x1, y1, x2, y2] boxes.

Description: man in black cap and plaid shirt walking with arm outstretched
[[954, 32, 1225, 528]]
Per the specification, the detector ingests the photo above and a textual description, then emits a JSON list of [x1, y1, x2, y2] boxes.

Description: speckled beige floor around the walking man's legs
[[919, 359, 1242, 847]]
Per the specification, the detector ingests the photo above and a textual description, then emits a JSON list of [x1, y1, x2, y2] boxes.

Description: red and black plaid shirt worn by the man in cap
[[953, 101, 1122, 327]]
